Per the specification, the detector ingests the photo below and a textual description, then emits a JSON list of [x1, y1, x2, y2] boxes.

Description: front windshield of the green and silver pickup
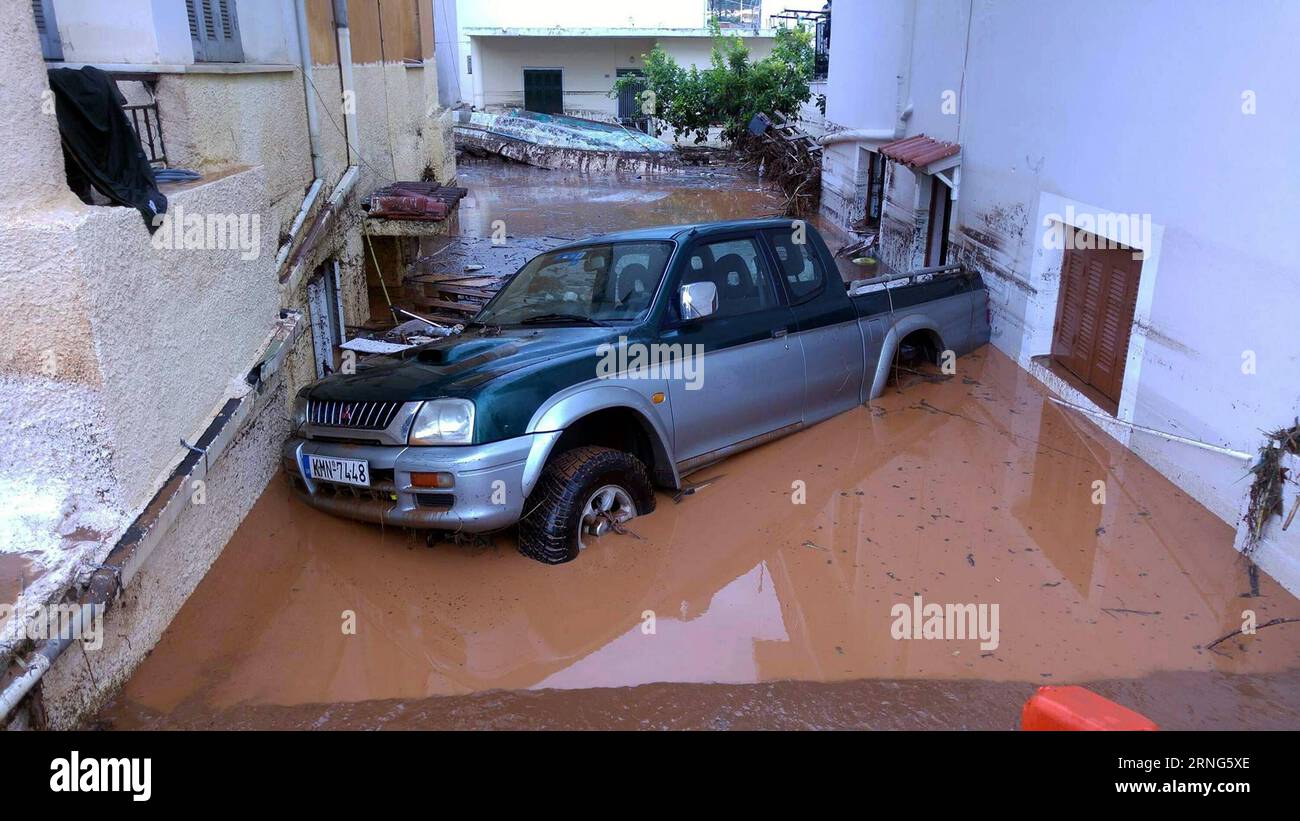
[[475, 242, 672, 325]]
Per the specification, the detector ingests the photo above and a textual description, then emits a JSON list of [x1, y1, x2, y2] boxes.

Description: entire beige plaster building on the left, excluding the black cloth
[[0, 0, 455, 726]]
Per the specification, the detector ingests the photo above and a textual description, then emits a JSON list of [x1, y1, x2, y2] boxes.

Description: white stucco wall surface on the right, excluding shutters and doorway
[[826, 0, 1300, 584]]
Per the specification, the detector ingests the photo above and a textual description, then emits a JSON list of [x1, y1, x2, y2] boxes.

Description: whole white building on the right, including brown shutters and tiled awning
[[823, 0, 1300, 590]]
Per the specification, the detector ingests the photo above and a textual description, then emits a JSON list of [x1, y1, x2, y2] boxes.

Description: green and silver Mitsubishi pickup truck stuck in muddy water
[[283, 220, 989, 564]]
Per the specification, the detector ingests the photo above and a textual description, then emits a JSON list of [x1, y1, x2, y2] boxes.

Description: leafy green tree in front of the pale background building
[[614, 22, 813, 143]]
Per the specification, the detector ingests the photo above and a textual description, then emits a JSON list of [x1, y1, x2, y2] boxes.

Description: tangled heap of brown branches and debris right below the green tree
[[736, 114, 822, 218]]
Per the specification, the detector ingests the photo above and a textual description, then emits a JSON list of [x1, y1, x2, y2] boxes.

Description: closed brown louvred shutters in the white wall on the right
[[1052, 234, 1141, 403]]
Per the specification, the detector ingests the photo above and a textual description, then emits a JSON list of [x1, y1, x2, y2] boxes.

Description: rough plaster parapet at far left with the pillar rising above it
[[0, 0, 292, 691]]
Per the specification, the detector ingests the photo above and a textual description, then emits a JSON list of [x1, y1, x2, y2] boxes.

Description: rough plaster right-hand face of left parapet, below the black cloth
[[75, 168, 278, 509]]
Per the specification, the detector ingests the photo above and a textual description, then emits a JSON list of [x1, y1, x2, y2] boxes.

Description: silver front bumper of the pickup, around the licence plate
[[281, 433, 559, 533]]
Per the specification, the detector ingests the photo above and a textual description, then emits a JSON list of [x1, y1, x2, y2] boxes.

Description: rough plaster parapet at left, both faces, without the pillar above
[[0, 169, 277, 558]]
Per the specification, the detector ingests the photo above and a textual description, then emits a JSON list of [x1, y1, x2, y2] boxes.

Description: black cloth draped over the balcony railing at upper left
[[49, 66, 166, 234]]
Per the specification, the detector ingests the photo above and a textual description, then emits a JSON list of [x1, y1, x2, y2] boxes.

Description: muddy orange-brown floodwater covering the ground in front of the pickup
[[100, 347, 1300, 727]]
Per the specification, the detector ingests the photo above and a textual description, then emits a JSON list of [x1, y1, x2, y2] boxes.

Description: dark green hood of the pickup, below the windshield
[[307, 326, 628, 401]]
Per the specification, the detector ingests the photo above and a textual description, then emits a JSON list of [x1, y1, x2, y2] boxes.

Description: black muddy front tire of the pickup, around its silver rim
[[519, 447, 655, 564]]
